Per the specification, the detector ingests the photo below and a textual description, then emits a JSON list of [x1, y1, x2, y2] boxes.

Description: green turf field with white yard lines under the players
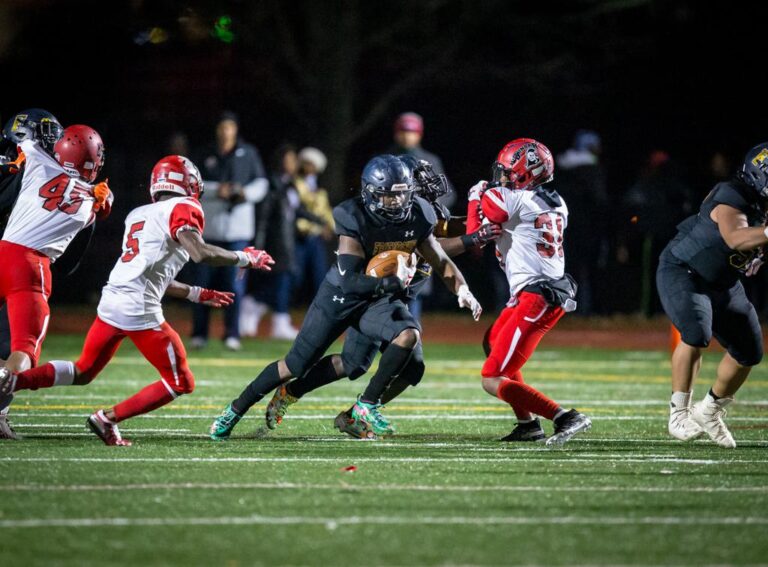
[[0, 336, 768, 566]]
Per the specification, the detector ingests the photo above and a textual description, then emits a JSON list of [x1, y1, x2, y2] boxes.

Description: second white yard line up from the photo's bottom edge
[[0, 482, 768, 494]]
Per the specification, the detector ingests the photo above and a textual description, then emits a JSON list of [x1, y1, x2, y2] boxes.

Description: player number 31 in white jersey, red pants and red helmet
[[467, 138, 591, 445]]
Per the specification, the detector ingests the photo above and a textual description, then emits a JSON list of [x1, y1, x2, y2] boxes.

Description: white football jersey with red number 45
[[3, 140, 95, 261]]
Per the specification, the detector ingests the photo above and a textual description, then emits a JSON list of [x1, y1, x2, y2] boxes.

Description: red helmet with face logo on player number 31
[[493, 138, 555, 189]]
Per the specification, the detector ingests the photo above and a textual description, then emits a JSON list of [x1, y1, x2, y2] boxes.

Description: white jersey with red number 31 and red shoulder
[[482, 187, 568, 303]]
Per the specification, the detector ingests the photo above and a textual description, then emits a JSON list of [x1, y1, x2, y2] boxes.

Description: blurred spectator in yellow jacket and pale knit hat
[[293, 148, 334, 297]]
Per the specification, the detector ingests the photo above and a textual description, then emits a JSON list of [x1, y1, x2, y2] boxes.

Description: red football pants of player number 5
[[75, 317, 195, 397]]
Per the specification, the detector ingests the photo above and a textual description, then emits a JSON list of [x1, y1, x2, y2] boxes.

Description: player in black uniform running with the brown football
[[210, 155, 482, 440]]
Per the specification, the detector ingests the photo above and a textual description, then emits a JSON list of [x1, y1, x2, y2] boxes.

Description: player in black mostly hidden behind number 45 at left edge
[[0, 108, 64, 439]]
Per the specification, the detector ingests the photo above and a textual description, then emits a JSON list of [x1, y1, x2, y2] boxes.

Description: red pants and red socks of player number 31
[[482, 292, 565, 419]]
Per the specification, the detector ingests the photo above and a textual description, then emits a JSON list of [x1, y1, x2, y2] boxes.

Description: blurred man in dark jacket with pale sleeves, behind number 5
[[192, 112, 269, 350]]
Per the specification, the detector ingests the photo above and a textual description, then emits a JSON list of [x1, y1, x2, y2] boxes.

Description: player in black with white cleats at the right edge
[[656, 143, 768, 448]]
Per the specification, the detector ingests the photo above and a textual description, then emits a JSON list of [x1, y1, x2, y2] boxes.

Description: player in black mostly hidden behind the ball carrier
[[256, 155, 501, 438]]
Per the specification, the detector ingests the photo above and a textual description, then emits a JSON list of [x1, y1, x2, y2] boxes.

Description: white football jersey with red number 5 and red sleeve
[[97, 197, 205, 331]]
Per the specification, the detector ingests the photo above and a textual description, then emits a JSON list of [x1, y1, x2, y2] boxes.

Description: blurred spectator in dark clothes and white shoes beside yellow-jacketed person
[[240, 144, 301, 340]]
